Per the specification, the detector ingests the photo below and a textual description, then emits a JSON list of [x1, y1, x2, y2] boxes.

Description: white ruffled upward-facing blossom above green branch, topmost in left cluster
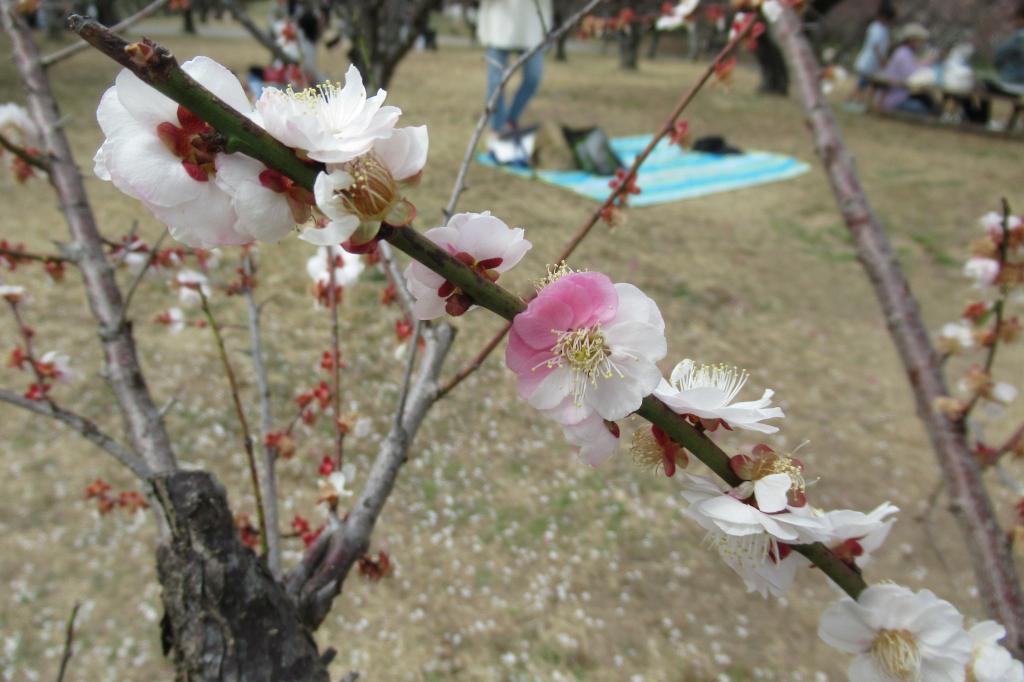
[[256, 66, 401, 164]]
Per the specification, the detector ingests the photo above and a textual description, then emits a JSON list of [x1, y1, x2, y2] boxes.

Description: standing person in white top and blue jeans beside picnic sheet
[[476, 0, 554, 137]]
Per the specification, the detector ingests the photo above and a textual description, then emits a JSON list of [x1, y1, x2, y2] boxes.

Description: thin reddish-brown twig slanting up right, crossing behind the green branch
[[440, 17, 754, 395]]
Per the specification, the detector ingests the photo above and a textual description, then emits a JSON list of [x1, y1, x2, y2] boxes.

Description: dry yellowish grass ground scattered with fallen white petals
[[0, 10, 1024, 682]]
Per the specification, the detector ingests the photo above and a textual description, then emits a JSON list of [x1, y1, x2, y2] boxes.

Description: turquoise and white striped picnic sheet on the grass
[[478, 135, 810, 206]]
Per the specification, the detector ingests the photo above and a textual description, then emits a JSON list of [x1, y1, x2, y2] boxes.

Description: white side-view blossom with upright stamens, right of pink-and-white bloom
[[654, 359, 785, 433]]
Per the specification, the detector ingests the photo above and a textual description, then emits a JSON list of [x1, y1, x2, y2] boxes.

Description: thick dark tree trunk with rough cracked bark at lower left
[[154, 471, 330, 682]]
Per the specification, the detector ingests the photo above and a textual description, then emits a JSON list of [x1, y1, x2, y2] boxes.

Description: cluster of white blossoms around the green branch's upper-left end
[[94, 56, 427, 248]]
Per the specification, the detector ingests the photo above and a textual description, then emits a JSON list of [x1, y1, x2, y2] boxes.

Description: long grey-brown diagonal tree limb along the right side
[[775, 9, 1024, 657]]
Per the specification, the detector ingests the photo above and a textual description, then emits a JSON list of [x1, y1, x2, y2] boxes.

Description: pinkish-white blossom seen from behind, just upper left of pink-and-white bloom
[[404, 211, 532, 319]]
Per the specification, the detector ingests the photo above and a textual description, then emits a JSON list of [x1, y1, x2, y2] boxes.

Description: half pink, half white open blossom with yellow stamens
[[505, 272, 667, 424]]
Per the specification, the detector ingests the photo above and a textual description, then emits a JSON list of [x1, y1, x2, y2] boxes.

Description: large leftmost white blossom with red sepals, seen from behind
[[94, 56, 252, 248]]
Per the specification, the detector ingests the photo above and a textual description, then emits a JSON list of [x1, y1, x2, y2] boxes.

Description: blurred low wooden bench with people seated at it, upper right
[[867, 76, 1024, 136]]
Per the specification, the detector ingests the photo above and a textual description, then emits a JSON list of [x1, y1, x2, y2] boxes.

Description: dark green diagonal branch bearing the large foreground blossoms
[[68, 15, 867, 599]]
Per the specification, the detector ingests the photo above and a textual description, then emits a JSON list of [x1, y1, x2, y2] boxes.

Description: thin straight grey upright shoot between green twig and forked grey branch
[[242, 251, 281, 579]]
